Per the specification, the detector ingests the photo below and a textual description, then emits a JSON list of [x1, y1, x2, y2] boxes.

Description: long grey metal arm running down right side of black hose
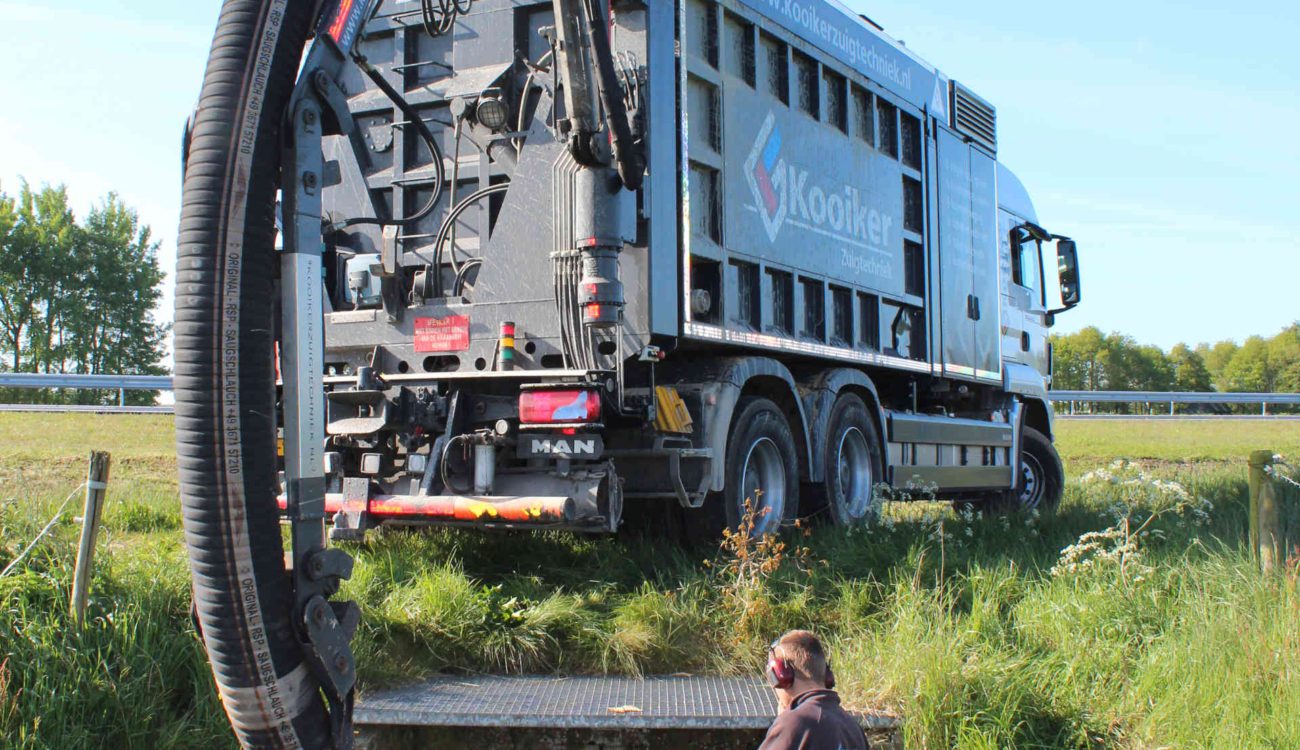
[[280, 30, 361, 749]]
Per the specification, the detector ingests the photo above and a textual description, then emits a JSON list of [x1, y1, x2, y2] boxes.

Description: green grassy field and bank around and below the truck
[[0, 413, 1300, 749]]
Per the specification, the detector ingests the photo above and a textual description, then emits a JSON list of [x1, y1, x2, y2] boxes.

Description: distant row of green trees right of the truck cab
[[1052, 321, 1300, 411]]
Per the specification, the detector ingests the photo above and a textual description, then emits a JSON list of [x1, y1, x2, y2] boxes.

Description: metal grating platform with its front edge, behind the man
[[355, 676, 901, 750]]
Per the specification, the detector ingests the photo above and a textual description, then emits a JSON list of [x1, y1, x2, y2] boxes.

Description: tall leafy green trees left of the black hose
[[0, 182, 169, 403]]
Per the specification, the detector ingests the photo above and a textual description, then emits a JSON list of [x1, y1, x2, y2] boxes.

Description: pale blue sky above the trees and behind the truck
[[0, 0, 1300, 348]]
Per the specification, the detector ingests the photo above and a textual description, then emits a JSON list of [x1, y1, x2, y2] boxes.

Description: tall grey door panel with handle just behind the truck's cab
[[937, 126, 1002, 380]]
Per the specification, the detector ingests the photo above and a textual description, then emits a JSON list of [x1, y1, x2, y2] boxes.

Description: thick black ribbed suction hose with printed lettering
[[176, 0, 330, 749]]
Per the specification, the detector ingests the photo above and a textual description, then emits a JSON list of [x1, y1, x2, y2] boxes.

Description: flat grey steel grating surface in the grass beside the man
[[355, 676, 897, 729]]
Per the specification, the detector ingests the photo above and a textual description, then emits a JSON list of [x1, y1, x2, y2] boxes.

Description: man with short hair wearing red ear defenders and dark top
[[759, 630, 867, 750]]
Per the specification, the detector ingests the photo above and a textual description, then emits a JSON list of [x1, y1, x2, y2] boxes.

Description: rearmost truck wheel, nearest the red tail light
[[714, 396, 800, 537]]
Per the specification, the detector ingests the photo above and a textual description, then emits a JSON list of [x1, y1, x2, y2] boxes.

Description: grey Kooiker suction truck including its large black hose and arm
[[176, 0, 1080, 747]]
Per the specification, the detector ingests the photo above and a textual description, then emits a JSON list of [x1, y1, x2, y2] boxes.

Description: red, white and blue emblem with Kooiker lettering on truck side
[[745, 112, 894, 255]]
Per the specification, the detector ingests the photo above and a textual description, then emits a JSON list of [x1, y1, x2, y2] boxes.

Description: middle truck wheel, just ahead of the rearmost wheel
[[824, 394, 883, 526]]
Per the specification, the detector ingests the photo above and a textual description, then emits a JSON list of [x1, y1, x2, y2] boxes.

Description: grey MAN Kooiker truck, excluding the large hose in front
[[301, 0, 1079, 537]]
